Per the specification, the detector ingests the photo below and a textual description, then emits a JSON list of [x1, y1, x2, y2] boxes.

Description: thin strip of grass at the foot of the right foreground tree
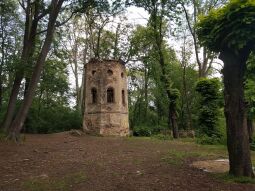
[[213, 173, 255, 184]]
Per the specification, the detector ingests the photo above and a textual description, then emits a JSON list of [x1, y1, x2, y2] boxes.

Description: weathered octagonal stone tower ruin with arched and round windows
[[83, 59, 129, 136]]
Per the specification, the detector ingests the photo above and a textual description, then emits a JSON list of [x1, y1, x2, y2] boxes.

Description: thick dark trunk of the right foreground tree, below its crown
[[220, 49, 254, 177]]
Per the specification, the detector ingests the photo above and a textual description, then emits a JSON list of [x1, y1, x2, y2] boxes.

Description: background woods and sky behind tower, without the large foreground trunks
[[0, 0, 255, 144]]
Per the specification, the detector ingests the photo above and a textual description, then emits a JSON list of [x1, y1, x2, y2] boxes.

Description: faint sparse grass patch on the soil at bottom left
[[22, 172, 87, 191]]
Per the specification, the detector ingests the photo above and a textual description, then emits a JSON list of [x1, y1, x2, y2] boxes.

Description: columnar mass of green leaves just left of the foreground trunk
[[196, 78, 220, 139]]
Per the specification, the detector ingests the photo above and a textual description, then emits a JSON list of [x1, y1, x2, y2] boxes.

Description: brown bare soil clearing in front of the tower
[[0, 132, 255, 191]]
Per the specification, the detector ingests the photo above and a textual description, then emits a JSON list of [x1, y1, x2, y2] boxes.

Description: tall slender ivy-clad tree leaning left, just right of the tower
[[130, 0, 182, 138]]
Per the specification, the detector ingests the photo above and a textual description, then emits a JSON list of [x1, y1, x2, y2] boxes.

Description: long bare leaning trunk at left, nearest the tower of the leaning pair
[[9, 0, 64, 140]]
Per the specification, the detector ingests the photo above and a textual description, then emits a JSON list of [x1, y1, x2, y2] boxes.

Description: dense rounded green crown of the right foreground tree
[[197, 0, 255, 52]]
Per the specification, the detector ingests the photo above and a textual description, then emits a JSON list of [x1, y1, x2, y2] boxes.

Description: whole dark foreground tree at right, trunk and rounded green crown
[[197, 0, 255, 177]]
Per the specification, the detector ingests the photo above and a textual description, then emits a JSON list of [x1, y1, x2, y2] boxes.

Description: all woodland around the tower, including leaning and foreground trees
[[0, 0, 255, 176]]
